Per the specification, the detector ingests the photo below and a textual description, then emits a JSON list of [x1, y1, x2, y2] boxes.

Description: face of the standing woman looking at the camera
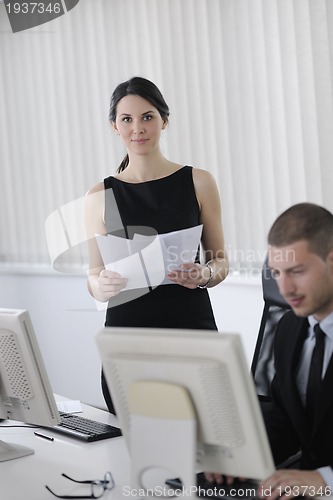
[[112, 95, 167, 155]]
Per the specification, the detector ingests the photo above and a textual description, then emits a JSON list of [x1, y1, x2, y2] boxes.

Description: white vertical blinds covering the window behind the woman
[[0, 0, 333, 272]]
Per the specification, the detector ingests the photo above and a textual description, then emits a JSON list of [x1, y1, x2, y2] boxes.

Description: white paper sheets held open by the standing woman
[[96, 225, 202, 290]]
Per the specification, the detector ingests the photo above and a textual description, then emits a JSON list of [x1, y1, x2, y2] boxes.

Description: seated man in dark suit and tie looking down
[[206, 203, 333, 500]]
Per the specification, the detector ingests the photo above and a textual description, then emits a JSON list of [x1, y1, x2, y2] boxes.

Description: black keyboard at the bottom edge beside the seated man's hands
[[166, 472, 258, 500]]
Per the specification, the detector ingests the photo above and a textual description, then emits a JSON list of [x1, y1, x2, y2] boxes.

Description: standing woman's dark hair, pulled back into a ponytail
[[109, 76, 170, 173]]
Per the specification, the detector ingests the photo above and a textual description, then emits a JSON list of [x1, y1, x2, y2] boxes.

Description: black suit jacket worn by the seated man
[[265, 311, 333, 469]]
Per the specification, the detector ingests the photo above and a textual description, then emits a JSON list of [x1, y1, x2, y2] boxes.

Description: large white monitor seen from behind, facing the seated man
[[96, 326, 274, 486]]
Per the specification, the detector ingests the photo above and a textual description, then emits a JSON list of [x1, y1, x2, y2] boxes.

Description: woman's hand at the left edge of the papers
[[89, 269, 128, 302]]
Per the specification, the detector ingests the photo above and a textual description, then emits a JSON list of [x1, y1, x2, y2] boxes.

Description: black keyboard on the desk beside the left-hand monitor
[[50, 412, 121, 443]]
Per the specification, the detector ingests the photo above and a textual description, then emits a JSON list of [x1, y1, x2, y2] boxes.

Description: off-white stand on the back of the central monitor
[[128, 381, 197, 492]]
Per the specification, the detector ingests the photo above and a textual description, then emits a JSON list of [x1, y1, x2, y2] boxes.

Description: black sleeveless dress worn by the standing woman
[[102, 166, 217, 413]]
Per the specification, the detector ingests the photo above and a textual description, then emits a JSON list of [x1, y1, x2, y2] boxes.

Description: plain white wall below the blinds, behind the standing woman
[[0, 271, 263, 407]]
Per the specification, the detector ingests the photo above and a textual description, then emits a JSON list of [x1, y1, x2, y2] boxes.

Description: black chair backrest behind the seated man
[[251, 259, 290, 401]]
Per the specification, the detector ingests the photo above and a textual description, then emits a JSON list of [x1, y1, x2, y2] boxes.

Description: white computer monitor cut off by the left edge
[[0, 309, 60, 462]]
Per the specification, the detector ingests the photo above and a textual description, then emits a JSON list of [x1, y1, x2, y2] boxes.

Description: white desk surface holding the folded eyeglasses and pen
[[0, 398, 130, 500]]
